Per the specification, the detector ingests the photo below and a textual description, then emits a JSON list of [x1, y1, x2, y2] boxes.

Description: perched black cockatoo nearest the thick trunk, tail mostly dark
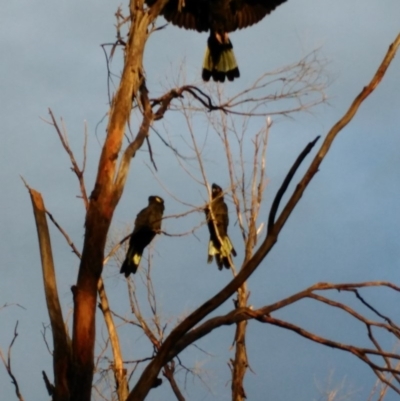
[[120, 196, 164, 277]]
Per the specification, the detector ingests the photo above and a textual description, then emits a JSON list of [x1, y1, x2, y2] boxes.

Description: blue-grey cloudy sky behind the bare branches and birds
[[0, 0, 400, 401]]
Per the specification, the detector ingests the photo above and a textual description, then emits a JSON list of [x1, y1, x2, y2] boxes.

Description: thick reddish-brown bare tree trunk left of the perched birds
[[71, 1, 154, 401]]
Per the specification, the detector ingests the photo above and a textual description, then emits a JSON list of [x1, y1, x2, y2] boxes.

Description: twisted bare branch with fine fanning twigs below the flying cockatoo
[[151, 51, 326, 120]]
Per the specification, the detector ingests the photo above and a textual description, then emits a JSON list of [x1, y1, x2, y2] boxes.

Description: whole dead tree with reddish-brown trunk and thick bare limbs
[[19, 0, 400, 401]]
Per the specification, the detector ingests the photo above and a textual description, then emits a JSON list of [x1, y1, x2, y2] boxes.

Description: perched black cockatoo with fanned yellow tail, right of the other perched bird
[[205, 184, 236, 270]]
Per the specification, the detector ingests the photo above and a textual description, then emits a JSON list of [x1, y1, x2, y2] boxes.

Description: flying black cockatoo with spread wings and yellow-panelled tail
[[146, 0, 286, 82]]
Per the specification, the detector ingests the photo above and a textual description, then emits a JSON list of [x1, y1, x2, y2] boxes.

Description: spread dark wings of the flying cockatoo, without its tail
[[146, 0, 287, 32]]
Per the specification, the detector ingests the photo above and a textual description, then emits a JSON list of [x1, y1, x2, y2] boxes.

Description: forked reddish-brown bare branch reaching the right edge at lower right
[[158, 282, 400, 394]]
